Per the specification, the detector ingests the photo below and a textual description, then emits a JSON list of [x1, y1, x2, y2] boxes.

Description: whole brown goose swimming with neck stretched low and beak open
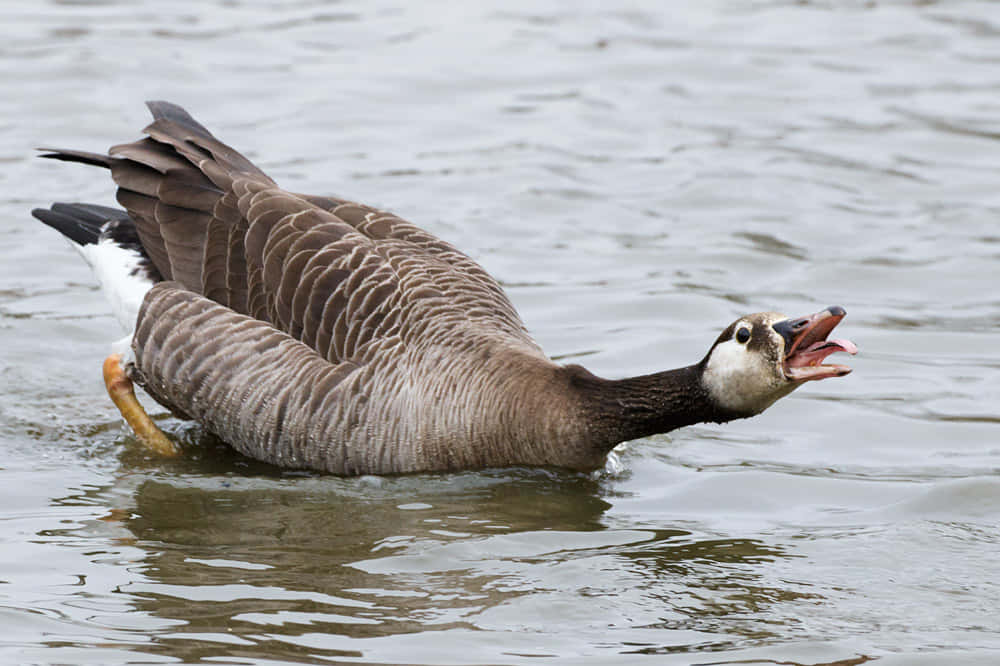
[[32, 101, 857, 475]]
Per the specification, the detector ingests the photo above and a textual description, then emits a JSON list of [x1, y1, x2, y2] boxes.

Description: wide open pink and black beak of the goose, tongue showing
[[773, 305, 858, 382]]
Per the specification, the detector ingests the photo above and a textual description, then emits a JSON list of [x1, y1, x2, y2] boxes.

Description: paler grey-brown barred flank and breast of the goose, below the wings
[[131, 282, 588, 475]]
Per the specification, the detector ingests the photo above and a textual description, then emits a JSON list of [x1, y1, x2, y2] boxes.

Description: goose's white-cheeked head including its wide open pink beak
[[701, 305, 858, 417]]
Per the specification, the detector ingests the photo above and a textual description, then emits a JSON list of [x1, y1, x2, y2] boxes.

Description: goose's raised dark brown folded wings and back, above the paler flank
[[47, 102, 537, 362]]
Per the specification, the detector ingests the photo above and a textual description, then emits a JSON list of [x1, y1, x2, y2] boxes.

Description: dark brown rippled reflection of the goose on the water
[[35, 446, 828, 661]]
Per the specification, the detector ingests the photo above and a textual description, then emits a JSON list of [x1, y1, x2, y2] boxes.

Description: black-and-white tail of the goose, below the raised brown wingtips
[[31, 203, 163, 335]]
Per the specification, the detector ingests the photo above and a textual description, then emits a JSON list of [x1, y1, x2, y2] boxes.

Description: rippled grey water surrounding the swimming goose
[[0, 0, 1000, 664]]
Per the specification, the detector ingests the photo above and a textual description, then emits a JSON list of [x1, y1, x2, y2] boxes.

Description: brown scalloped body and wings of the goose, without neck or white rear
[[46, 102, 584, 474]]
